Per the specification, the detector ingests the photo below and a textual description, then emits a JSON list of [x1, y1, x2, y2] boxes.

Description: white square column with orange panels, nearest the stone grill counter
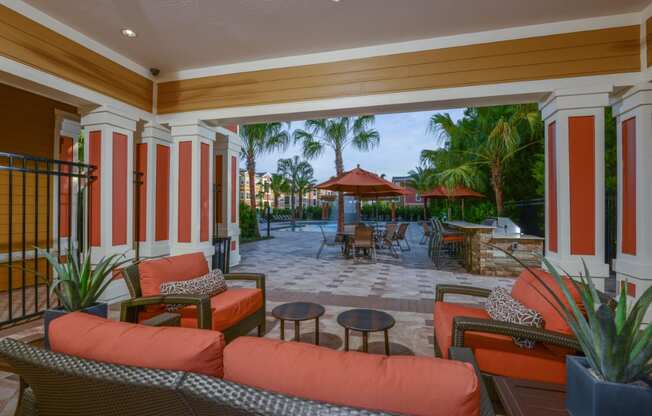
[[540, 89, 609, 289]]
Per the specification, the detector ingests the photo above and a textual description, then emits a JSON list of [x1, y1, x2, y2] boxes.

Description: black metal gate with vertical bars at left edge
[[0, 152, 95, 327]]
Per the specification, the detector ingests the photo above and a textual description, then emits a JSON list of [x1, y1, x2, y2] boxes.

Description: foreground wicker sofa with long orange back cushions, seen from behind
[[0, 313, 493, 416]]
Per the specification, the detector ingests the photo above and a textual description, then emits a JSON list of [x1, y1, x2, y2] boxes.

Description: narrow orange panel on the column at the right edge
[[621, 117, 636, 256]]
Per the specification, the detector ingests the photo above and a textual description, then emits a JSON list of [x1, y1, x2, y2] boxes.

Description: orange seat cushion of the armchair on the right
[[434, 302, 566, 384]]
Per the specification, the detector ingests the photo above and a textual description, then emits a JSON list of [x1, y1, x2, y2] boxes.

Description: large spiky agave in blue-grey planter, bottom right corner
[[530, 259, 652, 416]]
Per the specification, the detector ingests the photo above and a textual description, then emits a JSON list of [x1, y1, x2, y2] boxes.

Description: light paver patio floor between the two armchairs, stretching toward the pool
[[232, 225, 513, 356]]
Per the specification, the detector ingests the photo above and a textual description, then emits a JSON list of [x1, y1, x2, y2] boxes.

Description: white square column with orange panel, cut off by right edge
[[613, 83, 652, 323]]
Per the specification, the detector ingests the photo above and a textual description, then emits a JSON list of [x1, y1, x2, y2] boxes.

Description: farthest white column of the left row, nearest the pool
[[214, 128, 242, 266]]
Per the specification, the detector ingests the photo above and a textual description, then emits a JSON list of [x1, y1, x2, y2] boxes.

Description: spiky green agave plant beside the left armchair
[[38, 249, 128, 348]]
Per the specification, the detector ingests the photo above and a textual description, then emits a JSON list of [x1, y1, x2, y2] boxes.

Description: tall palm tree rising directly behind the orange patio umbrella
[[293, 116, 380, 230]]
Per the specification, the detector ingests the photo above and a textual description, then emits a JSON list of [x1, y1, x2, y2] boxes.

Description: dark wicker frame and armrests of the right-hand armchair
[[434, 285, 582, 357]]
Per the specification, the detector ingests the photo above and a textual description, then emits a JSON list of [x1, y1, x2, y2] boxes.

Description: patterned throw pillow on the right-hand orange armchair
[[485, 287, 544, 349]]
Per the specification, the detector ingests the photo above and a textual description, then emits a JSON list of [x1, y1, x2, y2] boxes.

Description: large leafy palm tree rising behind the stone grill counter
[[421, 104, 541, 216]]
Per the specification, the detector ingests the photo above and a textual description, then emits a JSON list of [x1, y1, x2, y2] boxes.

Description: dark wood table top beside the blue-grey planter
[[493, 376, 569, 416]]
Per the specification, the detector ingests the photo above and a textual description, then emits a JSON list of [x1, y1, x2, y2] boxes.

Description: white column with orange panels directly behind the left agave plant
[[81, 107, 137, 303]]
